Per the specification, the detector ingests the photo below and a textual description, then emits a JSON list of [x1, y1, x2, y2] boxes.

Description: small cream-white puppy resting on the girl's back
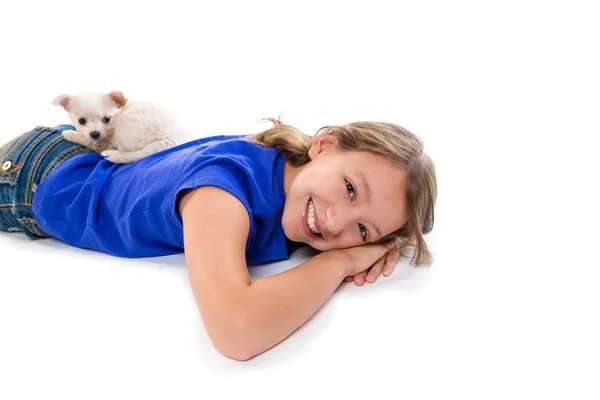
[[52, 91, 185, 164]]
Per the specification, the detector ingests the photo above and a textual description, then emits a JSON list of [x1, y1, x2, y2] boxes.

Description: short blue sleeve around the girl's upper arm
[[173, 164, 255, 250]]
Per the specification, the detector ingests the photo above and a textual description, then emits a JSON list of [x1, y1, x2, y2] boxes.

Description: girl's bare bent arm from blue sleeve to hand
[[179, 187, 387, 360]]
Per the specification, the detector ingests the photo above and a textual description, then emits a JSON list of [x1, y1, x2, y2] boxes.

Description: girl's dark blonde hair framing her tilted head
[[251, 118, 437, 265]]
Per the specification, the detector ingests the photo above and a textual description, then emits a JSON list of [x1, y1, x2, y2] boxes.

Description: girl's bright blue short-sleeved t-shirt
[[33, 135, 300, 264]]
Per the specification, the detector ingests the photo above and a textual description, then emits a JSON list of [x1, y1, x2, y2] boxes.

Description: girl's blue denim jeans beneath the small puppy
[[0, 125, 93, 238]]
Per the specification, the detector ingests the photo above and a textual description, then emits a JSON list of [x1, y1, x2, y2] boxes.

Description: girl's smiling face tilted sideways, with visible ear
[[282, 133, 408, 251]]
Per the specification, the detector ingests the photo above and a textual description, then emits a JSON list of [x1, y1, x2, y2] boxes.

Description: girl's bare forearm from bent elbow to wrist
[[238, 251, 347, 358]]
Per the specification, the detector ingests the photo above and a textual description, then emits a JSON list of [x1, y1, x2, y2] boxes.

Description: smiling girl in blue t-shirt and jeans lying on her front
[[0, 120, 437, 360]]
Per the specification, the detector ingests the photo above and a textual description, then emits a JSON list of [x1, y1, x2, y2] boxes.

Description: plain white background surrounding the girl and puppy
[[0, 0, 600, 400]]
